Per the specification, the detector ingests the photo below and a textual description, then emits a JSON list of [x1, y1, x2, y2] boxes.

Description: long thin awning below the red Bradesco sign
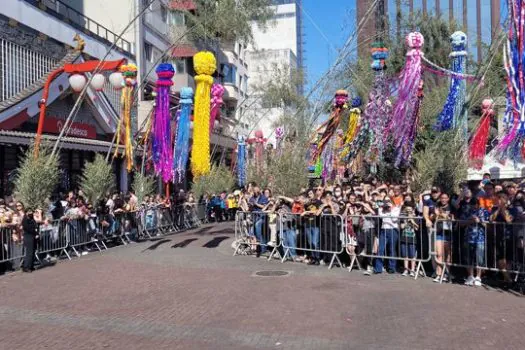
[[0, 130, 124, 153]]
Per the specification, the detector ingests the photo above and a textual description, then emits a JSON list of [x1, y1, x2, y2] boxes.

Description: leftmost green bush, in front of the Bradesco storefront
[[14, 144, 60, 210]]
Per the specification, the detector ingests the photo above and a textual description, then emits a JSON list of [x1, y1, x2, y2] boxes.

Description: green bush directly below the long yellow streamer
[[191, 165, 235, 198]]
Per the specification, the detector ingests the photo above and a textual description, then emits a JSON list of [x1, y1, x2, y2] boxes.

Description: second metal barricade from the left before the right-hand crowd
[[280, 213, 345, 269]]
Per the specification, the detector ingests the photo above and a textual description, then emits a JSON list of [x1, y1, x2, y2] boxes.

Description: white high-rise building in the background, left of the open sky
[[246, 0, 304, 143]]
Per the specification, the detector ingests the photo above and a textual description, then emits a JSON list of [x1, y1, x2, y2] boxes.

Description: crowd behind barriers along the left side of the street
[[0, 187, 229, 271]]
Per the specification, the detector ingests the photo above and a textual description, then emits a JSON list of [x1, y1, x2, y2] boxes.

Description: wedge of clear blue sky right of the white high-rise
[[303, 0, 356, 92]]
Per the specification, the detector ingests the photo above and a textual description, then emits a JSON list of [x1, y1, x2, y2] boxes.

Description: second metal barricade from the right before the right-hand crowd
[[345, 215, 431, 279]]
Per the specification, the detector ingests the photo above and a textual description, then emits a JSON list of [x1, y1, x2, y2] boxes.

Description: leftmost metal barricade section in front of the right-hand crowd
[[233, 211, 282, 260]]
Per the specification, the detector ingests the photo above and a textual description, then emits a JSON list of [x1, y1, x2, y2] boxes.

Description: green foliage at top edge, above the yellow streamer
[[175, 0, 274, 43]]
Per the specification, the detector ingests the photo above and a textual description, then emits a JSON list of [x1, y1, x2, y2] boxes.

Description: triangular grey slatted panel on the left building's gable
[[0, 39, 57, 101]]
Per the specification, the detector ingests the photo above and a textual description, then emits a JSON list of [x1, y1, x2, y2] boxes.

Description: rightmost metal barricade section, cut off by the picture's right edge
[[433, 217, 525, 284]]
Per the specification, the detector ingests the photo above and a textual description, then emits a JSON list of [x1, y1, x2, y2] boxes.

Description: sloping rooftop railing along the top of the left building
[[24, 0, 135, 56]]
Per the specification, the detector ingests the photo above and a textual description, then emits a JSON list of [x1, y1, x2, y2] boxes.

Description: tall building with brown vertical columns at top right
[[355, 0, 506, 61]]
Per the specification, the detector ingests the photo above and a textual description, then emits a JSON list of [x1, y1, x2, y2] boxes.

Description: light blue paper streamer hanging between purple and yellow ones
[[173, 87, 193, 183]]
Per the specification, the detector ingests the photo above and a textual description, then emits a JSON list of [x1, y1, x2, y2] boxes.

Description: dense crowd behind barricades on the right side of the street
[[236, 174, 525, 286]]
